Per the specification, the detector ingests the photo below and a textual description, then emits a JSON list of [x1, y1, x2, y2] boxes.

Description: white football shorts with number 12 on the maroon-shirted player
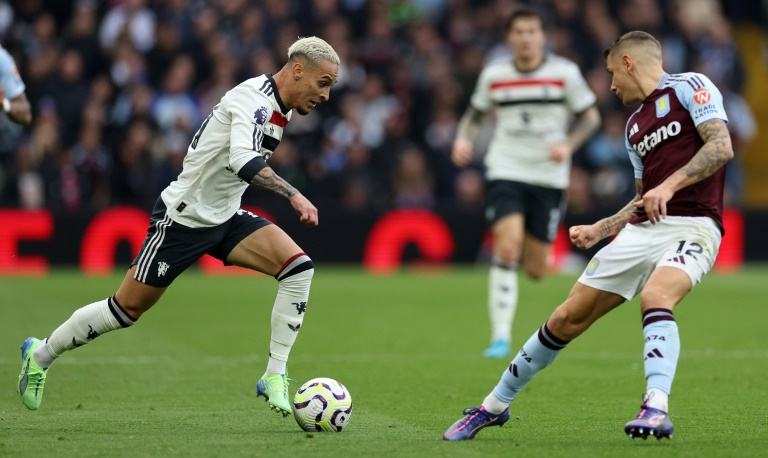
[[579, 216, 721, 301]]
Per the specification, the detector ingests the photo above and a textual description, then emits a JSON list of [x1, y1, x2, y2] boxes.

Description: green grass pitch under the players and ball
[[0, 265, 768, 457]]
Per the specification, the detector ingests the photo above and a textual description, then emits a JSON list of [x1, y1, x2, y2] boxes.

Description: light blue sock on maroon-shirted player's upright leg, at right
[[643, 309, 680, 394]]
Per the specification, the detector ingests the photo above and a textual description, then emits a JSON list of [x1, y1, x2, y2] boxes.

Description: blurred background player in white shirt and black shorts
[[452, 8, 600, 358]]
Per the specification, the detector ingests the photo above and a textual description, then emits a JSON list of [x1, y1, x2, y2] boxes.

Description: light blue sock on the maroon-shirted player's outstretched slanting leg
[[493, 323, 568, 404]]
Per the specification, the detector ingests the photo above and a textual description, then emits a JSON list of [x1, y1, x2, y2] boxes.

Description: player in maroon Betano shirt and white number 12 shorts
[[443, 31, 733, 440]]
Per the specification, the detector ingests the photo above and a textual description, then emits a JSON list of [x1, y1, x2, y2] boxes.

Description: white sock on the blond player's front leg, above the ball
[[267, 253, 315, 374]]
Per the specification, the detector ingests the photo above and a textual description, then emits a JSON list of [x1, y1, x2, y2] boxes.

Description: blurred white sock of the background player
[[488, 259, 517, 342]]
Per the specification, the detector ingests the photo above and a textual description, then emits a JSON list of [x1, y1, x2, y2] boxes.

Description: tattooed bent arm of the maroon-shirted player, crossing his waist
[[634, 118, 733, 224]]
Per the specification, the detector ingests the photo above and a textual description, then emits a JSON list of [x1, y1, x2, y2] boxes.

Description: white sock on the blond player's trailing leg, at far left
[[34, 296, 136, 367]]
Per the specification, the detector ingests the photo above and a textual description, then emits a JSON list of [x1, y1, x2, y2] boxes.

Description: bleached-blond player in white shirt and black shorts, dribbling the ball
[[18, 37, 340, 416]]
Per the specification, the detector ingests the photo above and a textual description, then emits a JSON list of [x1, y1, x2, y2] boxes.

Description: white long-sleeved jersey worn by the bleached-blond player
[[160, 74, 291, 227]]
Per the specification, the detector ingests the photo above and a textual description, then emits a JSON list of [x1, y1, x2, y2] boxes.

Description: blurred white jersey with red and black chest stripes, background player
[[471, 54, 596, 189]]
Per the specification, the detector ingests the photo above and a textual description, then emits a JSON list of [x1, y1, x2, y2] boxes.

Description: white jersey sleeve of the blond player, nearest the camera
[[227, 88, 272, 174]]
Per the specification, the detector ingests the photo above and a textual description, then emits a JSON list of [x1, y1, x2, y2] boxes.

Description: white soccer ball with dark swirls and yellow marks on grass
[[293, 377, 352, 432]]
